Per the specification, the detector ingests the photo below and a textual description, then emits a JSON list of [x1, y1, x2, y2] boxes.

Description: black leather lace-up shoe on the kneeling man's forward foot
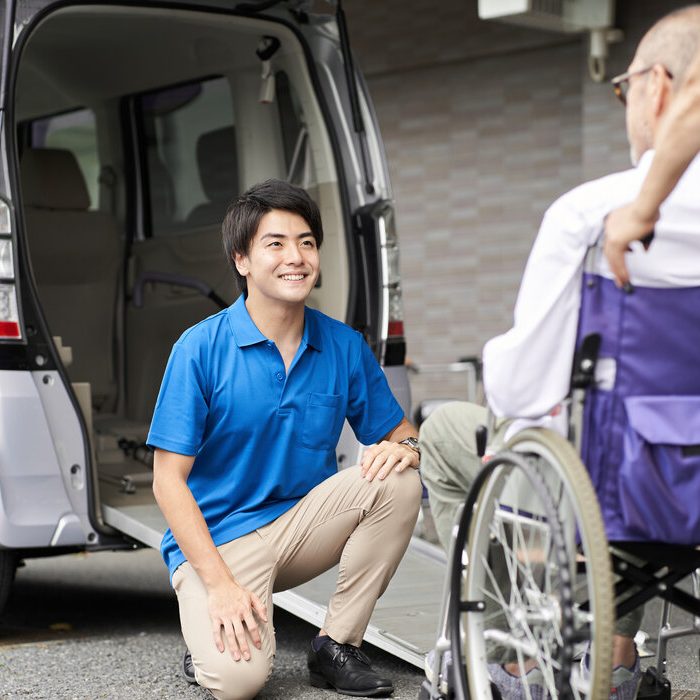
[[308, 639, 394, 697]]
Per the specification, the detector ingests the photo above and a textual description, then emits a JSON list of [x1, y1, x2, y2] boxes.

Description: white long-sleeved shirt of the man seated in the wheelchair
[[483, 151, 700, 434]]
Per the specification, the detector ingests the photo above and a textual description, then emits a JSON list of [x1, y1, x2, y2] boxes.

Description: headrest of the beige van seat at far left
[[20, 148, 90, 211]]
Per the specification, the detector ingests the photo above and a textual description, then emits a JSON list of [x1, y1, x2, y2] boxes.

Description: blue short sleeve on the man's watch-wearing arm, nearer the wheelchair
[[347, 334, 404, 445]]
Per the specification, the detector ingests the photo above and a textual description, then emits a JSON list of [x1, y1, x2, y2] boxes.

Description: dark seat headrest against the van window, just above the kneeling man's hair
[[197, 126, 238, 204]]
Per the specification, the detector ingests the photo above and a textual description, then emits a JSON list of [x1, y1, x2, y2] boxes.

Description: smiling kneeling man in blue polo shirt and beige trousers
[[148, 180, 421, 699]]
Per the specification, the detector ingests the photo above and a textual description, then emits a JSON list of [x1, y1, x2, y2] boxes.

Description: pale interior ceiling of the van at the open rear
[[15, 6, 288, 120]]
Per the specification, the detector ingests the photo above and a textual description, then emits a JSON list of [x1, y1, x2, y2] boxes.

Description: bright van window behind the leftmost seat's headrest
[[29, 109, 100, 209]]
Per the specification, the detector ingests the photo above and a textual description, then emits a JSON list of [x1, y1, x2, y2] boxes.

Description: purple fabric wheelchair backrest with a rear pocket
[[577, 274, 700, 544]]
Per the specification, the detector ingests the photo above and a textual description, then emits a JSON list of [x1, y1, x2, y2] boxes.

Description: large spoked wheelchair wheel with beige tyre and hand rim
[[451, 429, 613, 700]]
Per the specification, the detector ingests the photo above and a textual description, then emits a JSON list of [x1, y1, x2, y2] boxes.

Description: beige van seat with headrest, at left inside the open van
[[20, 148, 122, 410]]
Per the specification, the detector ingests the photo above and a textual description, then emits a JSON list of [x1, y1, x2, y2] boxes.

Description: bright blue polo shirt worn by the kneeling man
[[147, 296, 403, 576]]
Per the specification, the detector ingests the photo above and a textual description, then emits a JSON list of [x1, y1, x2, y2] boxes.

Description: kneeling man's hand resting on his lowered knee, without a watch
[[209, 581, 267, 661]]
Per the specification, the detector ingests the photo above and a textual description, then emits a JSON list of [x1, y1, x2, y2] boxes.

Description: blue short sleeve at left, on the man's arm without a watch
[[146, 341, 209, 456]]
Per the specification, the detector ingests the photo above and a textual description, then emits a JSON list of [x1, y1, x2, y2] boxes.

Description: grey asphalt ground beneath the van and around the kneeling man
[[0, 550, 700, 700]]
